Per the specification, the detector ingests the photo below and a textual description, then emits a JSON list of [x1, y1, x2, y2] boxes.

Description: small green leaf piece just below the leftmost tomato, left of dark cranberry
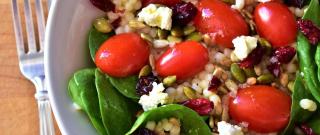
[[109, 76, 139, 100]]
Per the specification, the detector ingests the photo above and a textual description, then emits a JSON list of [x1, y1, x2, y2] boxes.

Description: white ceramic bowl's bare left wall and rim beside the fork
[[45, 0, 104, 135]]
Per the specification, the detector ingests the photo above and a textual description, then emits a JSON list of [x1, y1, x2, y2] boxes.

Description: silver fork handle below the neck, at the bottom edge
[[35, 91, 55, 135]]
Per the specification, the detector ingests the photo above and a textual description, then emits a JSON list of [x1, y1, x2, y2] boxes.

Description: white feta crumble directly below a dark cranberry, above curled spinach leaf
[[139, 82, 169, 111]]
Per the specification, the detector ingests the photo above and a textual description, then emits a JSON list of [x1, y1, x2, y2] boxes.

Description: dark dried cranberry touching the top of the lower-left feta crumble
[[136, 75, 159, 96]]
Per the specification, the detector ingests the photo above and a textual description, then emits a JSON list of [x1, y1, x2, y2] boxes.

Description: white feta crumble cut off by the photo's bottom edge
[[218, 121, 244, 135]]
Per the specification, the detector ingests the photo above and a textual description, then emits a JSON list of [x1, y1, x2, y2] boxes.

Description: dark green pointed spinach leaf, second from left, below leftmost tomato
[[95, 70, 135, 135]]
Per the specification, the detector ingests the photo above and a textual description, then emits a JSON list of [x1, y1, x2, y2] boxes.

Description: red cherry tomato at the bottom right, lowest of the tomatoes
[[229, 85, 291, 133]]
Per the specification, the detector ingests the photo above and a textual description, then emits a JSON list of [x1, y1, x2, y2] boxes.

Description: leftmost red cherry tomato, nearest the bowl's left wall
[[95, 33, 150, 77]]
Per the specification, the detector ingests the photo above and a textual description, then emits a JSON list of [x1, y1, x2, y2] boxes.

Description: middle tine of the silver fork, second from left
[[24, 0, 37, 53]]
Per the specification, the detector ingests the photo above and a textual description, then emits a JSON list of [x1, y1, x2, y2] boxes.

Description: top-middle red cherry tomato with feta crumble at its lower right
[[194, 0, 249, 48]]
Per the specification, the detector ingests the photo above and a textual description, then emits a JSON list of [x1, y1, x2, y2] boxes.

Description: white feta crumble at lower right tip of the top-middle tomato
[[232, 36, 258, 60]]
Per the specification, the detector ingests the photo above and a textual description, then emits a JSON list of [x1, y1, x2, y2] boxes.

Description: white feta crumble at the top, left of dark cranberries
[[138, 4, 172, 30]]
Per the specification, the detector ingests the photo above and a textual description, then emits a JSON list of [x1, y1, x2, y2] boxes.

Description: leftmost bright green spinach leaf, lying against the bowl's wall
[[70, 69, 107, 135]]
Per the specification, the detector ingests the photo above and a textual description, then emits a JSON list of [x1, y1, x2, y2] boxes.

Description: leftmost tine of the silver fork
[[12, 0, 25, 56]]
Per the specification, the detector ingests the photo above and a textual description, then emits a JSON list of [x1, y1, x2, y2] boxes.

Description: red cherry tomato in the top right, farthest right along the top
[[254, 2, 297, 47]]
